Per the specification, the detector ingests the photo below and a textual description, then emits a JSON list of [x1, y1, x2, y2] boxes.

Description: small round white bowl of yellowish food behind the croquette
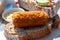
[[2, 8, 24, 22]]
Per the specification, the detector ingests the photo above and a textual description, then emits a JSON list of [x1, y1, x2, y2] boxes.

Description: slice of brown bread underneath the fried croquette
[[4, 23, 51, 40]]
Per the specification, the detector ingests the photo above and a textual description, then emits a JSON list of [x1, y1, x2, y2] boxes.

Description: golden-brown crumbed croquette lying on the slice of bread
[[12, 10, 49, 27]]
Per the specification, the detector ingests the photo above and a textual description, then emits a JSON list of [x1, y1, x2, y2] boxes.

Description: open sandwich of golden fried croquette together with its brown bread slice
[[4, 11, 52, 40]]
